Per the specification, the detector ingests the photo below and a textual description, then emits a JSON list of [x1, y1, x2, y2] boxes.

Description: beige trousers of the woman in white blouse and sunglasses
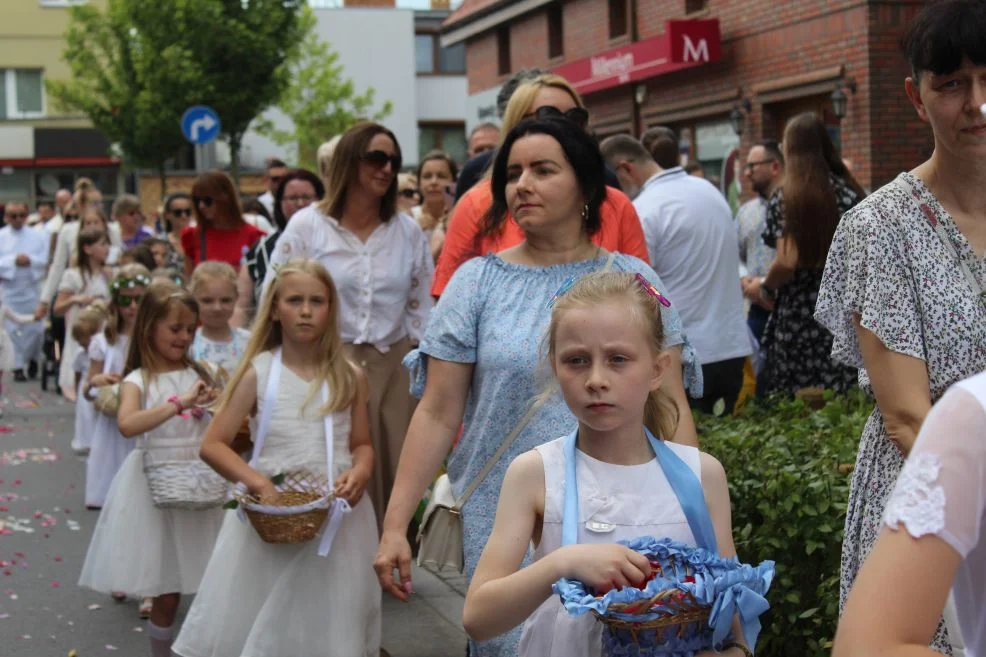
[[346, 338, 416, 529]]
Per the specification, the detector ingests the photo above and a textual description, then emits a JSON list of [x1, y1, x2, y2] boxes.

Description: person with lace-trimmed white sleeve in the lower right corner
[[832, 374, 986, 657]]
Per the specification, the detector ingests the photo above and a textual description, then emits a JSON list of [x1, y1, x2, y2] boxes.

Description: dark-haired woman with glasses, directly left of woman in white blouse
[[230, 169, 325, 328]]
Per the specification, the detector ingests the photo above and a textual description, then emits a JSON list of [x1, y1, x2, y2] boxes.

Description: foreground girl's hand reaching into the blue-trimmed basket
[[553, 543, 651, 595]]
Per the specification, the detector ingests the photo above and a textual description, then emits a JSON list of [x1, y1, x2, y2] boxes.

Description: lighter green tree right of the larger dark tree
[[253, 9, 393, 170]]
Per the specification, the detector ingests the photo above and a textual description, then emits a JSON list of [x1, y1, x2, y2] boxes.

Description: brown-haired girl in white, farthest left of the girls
[[53, 228, 110, 401]]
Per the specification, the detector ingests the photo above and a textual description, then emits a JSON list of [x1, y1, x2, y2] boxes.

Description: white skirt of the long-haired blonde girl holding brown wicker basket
[[171, 495, 382, 657]]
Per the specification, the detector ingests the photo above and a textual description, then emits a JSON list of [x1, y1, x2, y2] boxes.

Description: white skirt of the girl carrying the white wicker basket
[[79, 450, 223, 598]]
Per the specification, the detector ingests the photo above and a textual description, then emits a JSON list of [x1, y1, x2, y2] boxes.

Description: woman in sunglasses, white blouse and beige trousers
[[264, 123, 434, 523]]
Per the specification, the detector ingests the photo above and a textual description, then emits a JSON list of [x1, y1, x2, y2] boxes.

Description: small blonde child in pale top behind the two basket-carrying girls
[[190, 260, 250, 373]]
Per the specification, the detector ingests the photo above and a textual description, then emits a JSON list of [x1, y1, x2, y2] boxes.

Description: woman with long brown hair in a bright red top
[[181, 169, 266, 275]]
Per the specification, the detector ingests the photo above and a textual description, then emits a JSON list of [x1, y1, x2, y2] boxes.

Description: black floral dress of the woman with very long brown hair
[[760, 176, 860, 395]]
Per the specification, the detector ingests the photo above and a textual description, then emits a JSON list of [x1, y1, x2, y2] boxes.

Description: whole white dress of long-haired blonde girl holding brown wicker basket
[[172, 352, 381, 657]]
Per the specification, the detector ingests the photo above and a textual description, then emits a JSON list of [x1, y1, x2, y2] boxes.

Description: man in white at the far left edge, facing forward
[[0, 202, 48, 381]]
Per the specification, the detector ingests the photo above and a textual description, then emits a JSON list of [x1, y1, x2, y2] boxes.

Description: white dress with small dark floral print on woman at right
[[815, 173, 986, 654]]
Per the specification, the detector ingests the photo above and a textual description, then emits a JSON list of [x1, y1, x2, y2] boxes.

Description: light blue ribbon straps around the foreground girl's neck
[[561, 427, 719, 554]]
